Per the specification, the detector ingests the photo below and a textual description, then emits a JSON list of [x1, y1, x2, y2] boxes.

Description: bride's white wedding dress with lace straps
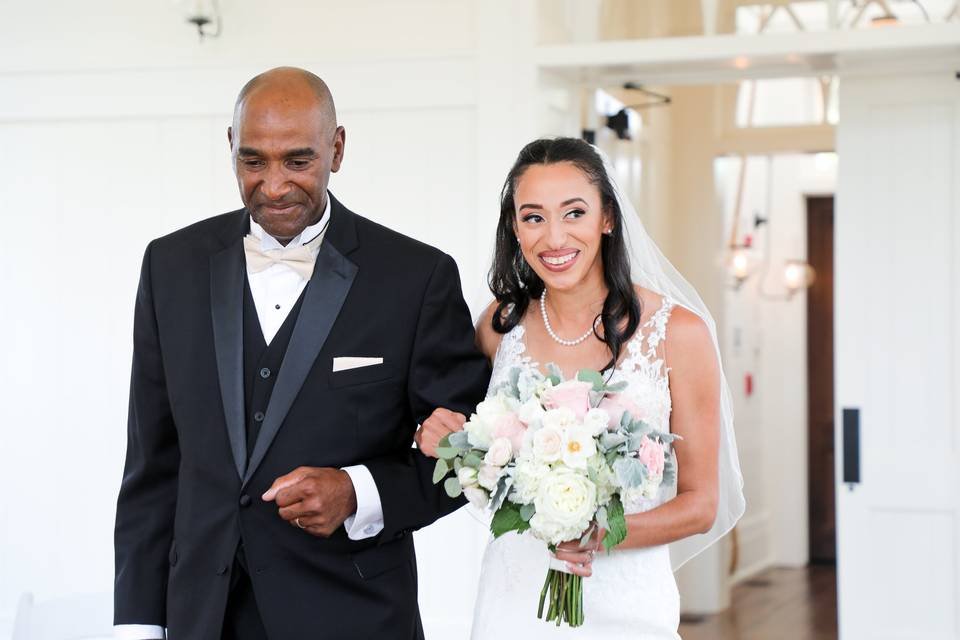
[[471, 298, 680, 640]]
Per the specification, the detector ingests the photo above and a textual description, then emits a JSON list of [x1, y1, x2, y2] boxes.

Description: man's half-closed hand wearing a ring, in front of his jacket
[[263, 467, 357, 538]]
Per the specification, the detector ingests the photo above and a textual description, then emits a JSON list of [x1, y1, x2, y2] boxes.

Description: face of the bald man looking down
[[227, 90, 345, 244]]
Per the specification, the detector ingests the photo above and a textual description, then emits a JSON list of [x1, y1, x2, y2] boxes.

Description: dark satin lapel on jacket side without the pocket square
[[210, 240, 247, 479]]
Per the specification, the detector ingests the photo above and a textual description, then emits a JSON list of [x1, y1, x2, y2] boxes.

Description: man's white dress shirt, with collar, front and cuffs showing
[[119, 193, 383, 640]]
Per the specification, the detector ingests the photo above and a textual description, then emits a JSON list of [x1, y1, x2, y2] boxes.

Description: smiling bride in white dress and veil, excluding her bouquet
[[416, 138, 743, 640]]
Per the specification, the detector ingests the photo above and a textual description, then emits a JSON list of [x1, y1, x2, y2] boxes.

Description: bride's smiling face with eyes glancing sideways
[[514, 162, 609, 290]]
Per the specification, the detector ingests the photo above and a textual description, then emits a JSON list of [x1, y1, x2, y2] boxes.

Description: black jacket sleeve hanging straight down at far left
[[114, 245, 180, 626]]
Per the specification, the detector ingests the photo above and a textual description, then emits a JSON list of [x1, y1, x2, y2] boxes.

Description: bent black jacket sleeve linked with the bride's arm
[[365, 255, 490, 541]]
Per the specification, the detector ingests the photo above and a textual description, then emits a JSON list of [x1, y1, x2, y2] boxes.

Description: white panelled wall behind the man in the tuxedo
[[0, 0, 537, 637]]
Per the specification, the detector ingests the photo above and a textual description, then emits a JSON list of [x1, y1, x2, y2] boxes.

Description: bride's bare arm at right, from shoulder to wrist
[[618, 306, 720, 548]]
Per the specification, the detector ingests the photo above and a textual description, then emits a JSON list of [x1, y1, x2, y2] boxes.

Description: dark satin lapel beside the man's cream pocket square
[[241, 242, 357, 486]]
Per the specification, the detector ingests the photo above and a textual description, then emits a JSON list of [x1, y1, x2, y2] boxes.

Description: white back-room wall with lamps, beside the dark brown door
[[716, 154, 836, 578]]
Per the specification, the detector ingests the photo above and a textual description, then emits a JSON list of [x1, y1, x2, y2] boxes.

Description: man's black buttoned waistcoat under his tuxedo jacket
[[243, 278, 306, 461]]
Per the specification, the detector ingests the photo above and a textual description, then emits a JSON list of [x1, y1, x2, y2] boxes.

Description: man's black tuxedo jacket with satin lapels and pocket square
[[115, 196, 489, 640]]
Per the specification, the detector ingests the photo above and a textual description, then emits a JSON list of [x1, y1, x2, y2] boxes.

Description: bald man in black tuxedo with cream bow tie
[[114, 68, 489, 640]]
